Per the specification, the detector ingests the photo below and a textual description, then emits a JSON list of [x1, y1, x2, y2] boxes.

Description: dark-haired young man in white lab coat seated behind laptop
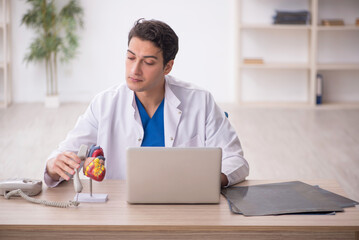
[[44, 19, 249, 187]]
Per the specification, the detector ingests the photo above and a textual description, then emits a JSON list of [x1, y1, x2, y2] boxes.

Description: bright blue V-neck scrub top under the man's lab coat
[[135, 95, 165, 147]]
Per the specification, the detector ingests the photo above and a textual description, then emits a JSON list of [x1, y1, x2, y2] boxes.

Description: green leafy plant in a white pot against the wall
[[21, 0, 83, 107]]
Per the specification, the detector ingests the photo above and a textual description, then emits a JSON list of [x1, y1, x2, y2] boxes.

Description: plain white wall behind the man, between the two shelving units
[[11, 0, 235, 102]]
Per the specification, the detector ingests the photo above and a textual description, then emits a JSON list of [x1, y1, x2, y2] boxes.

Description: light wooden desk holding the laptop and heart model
[[0, 180, 359, 239]]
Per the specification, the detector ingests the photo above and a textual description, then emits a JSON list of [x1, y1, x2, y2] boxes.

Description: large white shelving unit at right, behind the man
[[236, 0, 359, 108]]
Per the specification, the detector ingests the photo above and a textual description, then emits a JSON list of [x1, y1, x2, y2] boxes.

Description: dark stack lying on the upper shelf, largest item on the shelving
[[273, 10, 310, 25]]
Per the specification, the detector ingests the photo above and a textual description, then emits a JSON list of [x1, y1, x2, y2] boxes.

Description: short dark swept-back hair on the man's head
[[128, 18, 178, 66]]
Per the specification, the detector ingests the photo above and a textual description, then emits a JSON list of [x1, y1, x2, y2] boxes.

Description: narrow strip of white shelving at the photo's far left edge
[[0, 0, 11, 108]]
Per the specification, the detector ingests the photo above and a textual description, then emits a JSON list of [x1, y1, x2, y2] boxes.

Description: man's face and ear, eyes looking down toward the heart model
[[126, 37, 173, 94]]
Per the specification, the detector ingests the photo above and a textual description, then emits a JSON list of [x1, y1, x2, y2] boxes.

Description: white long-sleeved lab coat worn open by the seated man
[[44, 76, 249, 187]]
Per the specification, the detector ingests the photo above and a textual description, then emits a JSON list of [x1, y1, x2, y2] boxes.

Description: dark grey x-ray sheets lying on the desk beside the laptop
[[222, 181, 358, 216]]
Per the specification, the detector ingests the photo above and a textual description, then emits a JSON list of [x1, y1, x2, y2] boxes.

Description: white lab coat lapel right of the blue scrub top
[[163, 79, 182, 147]]
